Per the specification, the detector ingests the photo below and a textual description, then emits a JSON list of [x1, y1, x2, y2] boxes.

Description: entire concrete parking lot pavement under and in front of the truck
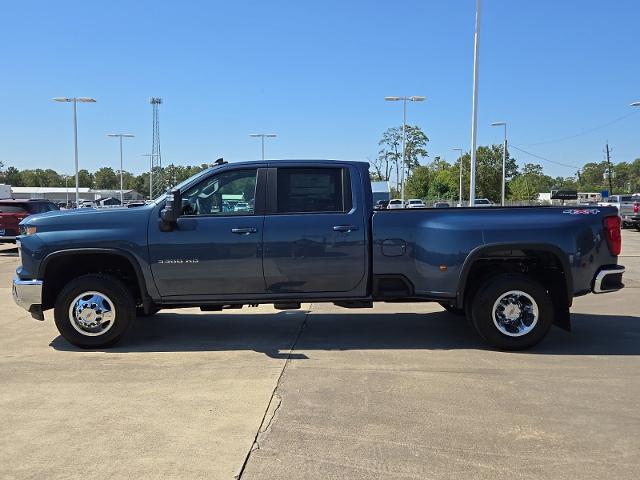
[[0, 231, 640, 480]]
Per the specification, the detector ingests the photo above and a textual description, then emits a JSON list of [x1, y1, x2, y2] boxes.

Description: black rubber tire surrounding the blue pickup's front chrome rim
[[54, 274, 136, 348]]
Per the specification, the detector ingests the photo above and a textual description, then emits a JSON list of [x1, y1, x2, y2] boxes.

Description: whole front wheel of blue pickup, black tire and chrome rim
[[54, 274, 136, 348]]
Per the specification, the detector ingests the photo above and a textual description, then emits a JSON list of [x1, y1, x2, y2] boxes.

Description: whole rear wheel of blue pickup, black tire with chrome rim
[[470, 273, 554, 350]]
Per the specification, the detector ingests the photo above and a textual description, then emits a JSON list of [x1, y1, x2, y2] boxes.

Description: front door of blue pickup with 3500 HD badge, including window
[[149, 168, 266, 297]]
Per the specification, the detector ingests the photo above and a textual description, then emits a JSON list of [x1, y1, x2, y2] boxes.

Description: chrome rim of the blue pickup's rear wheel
[[491, 290, 539, 337]]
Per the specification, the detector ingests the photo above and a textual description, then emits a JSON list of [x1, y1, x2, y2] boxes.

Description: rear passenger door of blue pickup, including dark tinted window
[[263, 166, 367, 296]]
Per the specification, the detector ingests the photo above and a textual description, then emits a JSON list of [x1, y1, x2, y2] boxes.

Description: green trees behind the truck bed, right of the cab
[[369, 126, 640, 202]]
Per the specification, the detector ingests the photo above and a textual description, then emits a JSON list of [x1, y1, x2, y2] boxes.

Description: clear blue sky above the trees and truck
[[0, 0, 640, 175]]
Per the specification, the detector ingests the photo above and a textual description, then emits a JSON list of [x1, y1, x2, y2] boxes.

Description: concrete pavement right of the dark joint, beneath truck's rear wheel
[[242, 231, 640, 480]]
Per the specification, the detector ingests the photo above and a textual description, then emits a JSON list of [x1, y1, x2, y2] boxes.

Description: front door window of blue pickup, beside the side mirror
[[182, 168, 257, 215]]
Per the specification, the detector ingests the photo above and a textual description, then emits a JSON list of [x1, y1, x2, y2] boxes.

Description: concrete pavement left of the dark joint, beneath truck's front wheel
[[0, 249, 305, 479]]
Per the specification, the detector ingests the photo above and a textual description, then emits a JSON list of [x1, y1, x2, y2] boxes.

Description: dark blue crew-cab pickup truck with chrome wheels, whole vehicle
[[13, 160, 624, 350]]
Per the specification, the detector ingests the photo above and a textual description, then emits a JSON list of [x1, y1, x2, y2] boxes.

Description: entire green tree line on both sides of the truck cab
[[0, 125, 640, 202]]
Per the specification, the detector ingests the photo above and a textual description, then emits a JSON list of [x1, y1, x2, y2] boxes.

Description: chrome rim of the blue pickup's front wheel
[[69, 291, 116, 337]]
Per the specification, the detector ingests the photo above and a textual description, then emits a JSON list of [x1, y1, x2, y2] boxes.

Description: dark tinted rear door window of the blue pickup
[[278, 168, 352, 213]]
